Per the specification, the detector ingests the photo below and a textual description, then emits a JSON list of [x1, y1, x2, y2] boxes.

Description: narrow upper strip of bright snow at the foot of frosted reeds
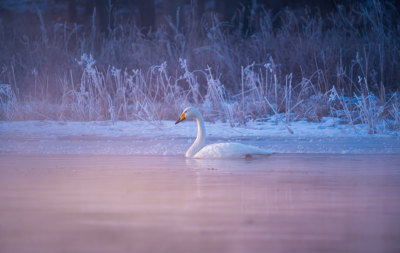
[[0, 118, 400, 138]]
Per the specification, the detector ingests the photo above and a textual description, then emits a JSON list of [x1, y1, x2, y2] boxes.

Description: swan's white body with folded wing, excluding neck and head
[[194, 143, 273, 158]]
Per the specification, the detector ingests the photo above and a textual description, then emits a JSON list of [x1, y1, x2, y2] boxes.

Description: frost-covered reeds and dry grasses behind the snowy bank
[[0, 1, 400, 133]]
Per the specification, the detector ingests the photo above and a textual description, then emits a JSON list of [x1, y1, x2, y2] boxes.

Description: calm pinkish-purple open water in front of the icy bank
[[0, 154, 400, 252]]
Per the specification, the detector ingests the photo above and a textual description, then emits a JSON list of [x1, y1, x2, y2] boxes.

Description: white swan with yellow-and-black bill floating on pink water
[[175, 107, 272, 158]]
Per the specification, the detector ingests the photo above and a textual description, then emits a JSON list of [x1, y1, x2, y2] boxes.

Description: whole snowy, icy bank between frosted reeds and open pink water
[[0, 118, 400, 155]]
